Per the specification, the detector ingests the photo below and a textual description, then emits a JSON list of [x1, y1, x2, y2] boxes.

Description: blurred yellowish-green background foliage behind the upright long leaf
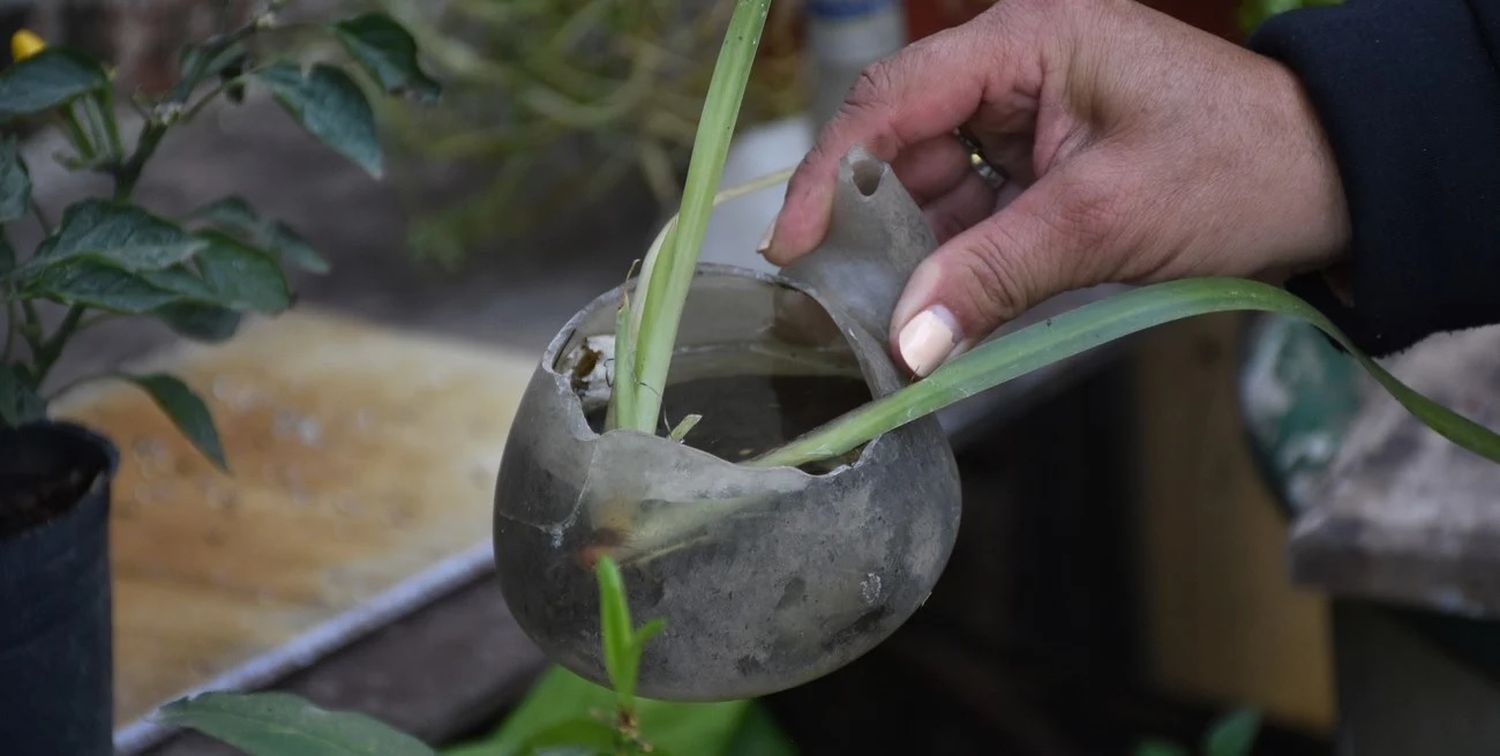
[[377, 0, 803, 265]]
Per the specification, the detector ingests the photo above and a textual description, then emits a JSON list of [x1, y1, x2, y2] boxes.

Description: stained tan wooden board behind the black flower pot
[[59, 312, 546, 726]]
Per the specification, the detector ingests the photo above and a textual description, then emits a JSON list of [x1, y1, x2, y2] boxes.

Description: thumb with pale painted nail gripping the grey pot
[[890, 168, 1115, 378]]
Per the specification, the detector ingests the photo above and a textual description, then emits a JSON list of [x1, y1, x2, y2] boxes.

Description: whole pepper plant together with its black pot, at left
[[0, 3, 438, 755]]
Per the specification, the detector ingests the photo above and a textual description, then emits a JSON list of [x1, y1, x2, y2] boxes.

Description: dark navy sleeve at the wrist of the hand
[[1250, 0, 1500, 354]]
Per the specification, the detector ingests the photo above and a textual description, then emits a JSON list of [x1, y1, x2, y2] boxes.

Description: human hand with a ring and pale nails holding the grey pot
[[761, 0, 1350, 377]]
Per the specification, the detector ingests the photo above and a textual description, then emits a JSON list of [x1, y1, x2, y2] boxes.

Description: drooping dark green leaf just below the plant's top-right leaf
[[255, 63, 381, 177]]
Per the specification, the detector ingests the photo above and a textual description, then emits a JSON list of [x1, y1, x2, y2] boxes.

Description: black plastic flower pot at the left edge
[[0, 423, 119, 756]]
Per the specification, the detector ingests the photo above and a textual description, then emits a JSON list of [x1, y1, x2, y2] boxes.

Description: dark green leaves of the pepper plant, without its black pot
[[0, 3, 440, 468]]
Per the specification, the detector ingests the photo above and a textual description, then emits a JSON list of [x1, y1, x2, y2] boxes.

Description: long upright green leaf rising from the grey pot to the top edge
[[621, 0, 771, 432]]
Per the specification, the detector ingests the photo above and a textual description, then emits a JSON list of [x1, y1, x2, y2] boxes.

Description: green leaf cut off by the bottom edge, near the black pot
[[156, 693, 434, 756]]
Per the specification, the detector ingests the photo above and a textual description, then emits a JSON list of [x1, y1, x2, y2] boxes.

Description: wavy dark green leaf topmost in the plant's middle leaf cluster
[[24, 200, 204, 272]]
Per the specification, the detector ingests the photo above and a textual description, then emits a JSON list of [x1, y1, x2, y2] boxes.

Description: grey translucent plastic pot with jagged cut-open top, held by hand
[[495, 155, 960, 701]]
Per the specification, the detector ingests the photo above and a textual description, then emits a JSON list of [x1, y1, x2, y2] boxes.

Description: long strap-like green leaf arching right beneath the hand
[[752, 278, 1500, 465]]
